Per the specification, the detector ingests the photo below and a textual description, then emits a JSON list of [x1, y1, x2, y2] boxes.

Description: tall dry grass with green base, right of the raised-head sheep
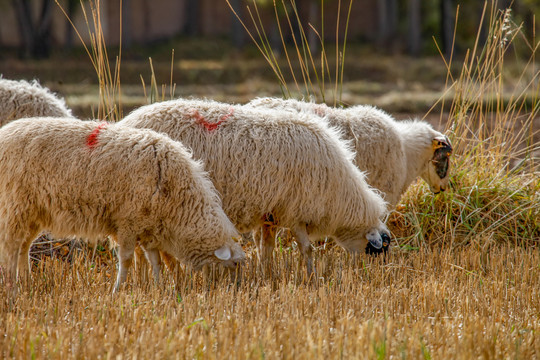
[[396, 2, 540, 246]]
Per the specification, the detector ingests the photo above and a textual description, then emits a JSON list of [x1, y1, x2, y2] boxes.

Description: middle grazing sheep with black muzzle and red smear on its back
[[119, 99, 388, 274]]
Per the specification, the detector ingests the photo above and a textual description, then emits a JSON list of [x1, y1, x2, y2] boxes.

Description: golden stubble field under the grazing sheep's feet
[[0, 242, 540, 359]]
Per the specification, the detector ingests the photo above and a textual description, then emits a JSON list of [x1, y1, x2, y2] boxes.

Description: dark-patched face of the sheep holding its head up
[[422, 134, 452, 194]]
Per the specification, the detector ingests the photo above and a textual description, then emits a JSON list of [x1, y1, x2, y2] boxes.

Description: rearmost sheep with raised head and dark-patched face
[[249, 98, 452, 208]]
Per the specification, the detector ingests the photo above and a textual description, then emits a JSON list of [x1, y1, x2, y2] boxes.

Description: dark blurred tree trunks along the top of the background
[[0, 0, 540, 58]]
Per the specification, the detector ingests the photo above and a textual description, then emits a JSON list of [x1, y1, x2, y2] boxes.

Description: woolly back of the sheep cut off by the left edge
[[0, 78, 72, 126]]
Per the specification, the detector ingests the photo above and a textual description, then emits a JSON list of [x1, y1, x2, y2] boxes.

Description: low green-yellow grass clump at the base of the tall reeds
[[390, 164, 540, 246]]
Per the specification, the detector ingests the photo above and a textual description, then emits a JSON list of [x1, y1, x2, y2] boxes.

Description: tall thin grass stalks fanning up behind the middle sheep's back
[[225, 0, 353, 106]]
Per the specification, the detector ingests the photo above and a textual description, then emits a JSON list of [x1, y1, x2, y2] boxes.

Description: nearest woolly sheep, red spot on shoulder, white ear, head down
[[0, 117, 245, 291]]
